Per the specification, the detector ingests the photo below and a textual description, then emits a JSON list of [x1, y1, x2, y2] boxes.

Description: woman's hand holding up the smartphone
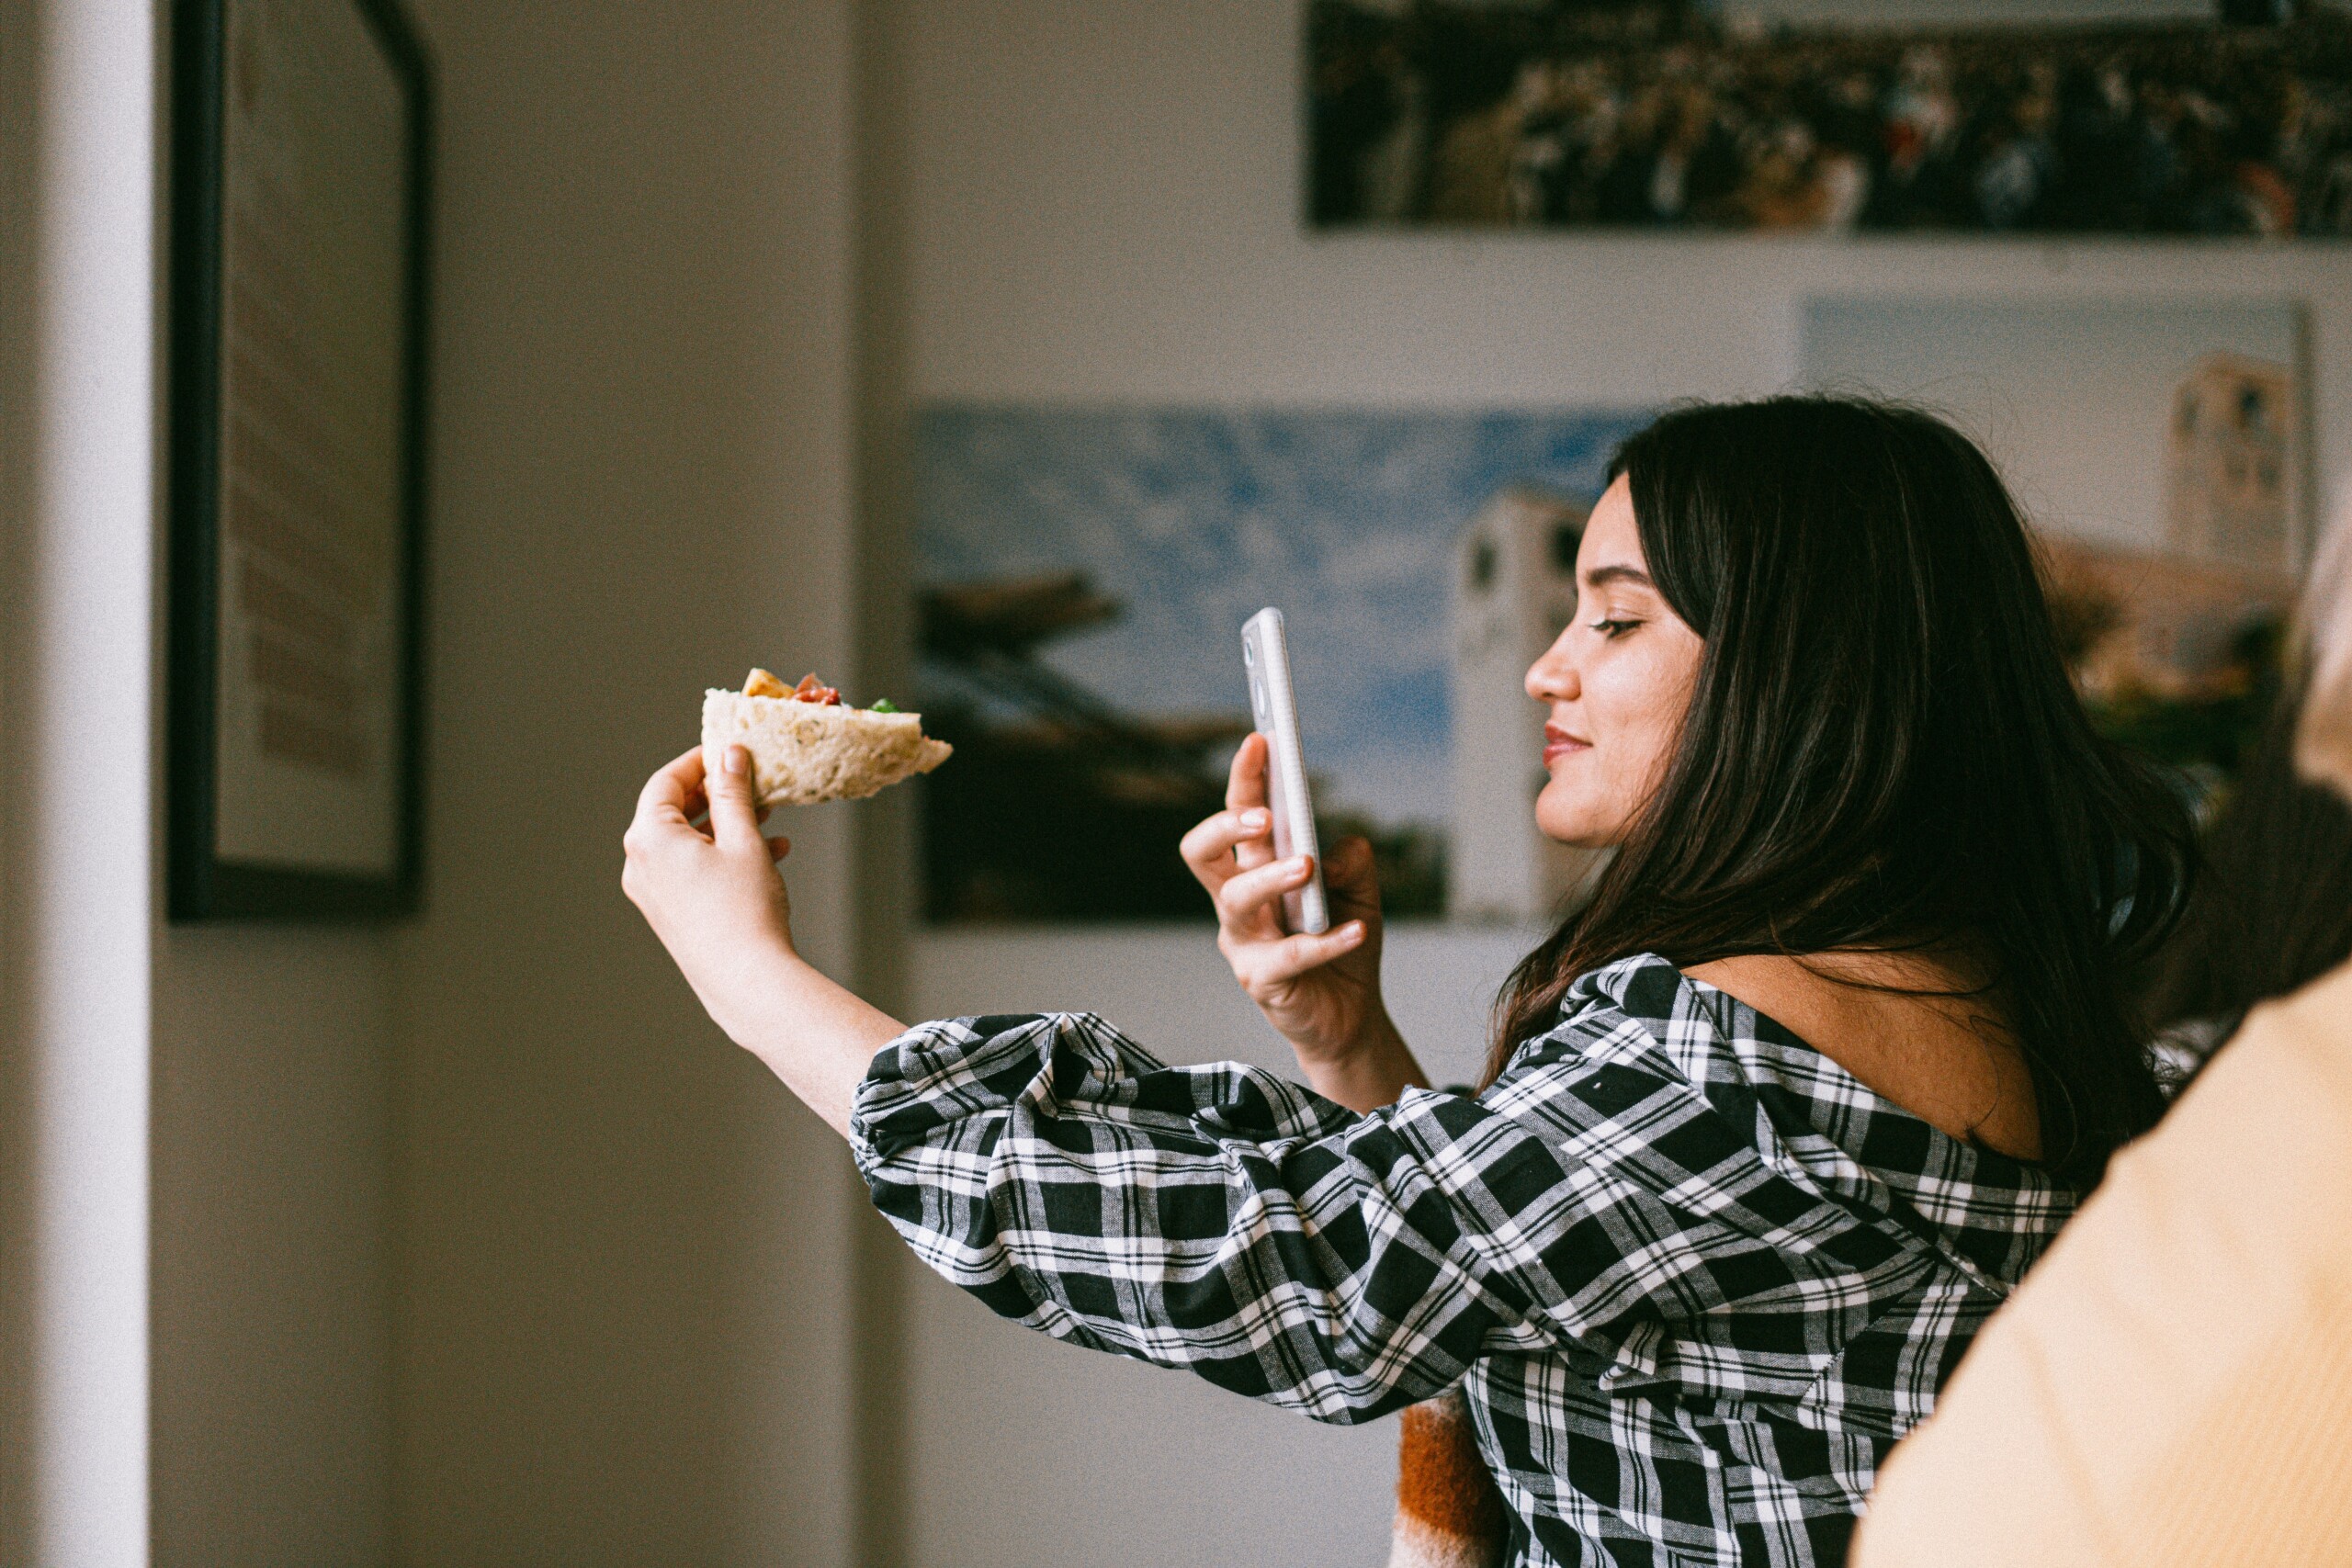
[[1183, 736, 1428, 1110]]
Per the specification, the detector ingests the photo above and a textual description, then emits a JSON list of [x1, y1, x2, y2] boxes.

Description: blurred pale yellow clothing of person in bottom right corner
[[1853, 964, 2352, 1568]]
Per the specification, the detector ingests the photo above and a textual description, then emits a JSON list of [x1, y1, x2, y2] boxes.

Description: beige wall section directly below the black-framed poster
[[148, 926, 393, 1568]]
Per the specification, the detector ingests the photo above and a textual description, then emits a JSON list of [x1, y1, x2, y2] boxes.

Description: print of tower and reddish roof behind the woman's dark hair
[[1799, 294, 2319, 802]]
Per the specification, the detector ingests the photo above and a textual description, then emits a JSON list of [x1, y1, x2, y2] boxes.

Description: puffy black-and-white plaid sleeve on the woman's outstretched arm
[[849, 1013, 1576, 1422]]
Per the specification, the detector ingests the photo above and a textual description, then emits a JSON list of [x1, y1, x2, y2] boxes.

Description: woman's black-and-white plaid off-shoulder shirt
[[852, 957, 2072, 1565]]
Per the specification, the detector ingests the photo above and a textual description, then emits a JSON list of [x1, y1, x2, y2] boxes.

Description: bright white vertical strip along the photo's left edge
[[0, 0, 155, 1565]]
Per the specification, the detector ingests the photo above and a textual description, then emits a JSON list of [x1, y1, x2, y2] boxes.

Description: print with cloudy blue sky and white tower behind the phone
[[915, 402, 1649, 924]]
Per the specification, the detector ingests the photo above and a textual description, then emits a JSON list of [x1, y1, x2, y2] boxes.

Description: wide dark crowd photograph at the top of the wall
[[1303, 0, 2352, 237]]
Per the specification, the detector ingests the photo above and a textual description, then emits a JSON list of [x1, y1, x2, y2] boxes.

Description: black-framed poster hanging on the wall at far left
[[167, 0, 433, 919]]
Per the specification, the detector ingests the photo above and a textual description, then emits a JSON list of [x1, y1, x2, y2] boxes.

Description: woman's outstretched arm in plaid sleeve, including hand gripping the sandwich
[[621, 748, 1569, 1420]]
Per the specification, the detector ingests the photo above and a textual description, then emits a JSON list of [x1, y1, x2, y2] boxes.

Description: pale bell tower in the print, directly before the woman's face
[[1446, 489, 1595, 921]]
